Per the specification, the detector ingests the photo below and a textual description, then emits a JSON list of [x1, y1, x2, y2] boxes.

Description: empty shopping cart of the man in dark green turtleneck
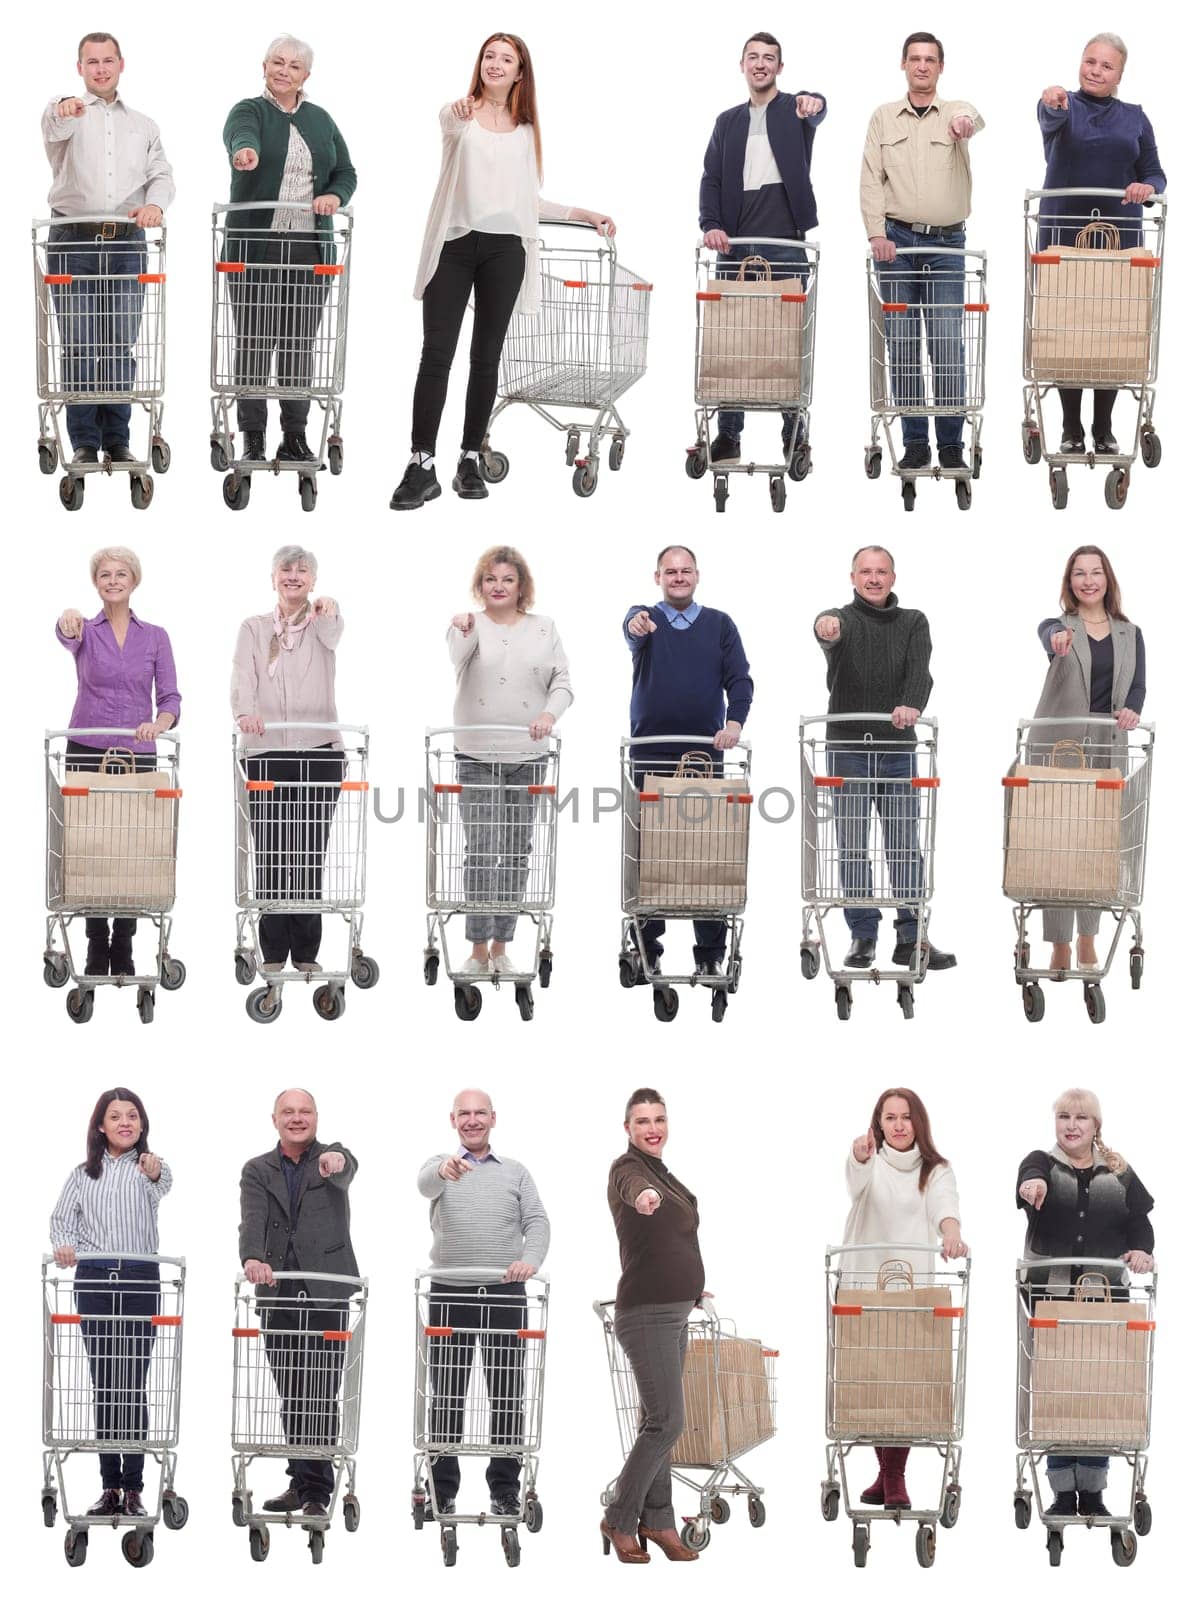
[[799, 712, 941, 1022]]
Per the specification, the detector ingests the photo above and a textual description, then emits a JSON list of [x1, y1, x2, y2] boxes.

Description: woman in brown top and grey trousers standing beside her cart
[[600, 1090, 704, 1563]]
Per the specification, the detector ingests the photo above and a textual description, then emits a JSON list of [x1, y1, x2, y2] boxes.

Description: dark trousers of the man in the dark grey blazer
[[259, 1301, 340, 1506]]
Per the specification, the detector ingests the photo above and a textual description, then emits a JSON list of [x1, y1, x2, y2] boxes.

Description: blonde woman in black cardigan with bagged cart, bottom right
[[1017, 1090, 1153, 1517]]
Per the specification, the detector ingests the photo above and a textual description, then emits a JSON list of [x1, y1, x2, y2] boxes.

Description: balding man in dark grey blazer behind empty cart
[[239, 1090, 359, 1517]]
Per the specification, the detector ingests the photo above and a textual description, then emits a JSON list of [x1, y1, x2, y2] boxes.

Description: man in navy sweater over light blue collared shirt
[[623, 544, 754, 973]]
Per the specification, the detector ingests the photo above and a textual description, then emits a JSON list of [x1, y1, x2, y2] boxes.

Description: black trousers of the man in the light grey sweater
[[429, 1283, 528, 1506]]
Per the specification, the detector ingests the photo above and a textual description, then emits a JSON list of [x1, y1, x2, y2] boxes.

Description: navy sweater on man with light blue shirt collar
[[623, 602, 754, 739]]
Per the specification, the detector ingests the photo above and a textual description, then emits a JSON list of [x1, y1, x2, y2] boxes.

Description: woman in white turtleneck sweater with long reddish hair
[[844, 1088, 970, 1510]]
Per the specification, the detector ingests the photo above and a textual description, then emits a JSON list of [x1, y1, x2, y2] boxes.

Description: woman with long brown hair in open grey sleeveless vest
[[1036, 544, 1145, 971]]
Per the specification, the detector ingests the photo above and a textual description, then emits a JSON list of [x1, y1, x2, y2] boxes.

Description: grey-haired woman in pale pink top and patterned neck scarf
[[231, 544, 346, 973]]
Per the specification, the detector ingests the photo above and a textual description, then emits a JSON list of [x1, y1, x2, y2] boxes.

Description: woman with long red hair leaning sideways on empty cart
[[391, 34, 616, 510]]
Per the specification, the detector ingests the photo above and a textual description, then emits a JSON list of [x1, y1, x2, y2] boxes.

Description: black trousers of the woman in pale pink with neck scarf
[[245, 744, 346, 962]]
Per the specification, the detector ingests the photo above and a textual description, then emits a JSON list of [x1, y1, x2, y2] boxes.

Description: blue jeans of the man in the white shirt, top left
[[46, 227, 146, 450]]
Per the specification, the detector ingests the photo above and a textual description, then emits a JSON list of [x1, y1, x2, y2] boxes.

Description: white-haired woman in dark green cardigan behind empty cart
[[224, 34, 359, 462]]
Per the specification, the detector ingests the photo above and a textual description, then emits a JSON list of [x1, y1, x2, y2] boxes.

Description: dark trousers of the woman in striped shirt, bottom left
[[75, 1258, 158, 1493]]
